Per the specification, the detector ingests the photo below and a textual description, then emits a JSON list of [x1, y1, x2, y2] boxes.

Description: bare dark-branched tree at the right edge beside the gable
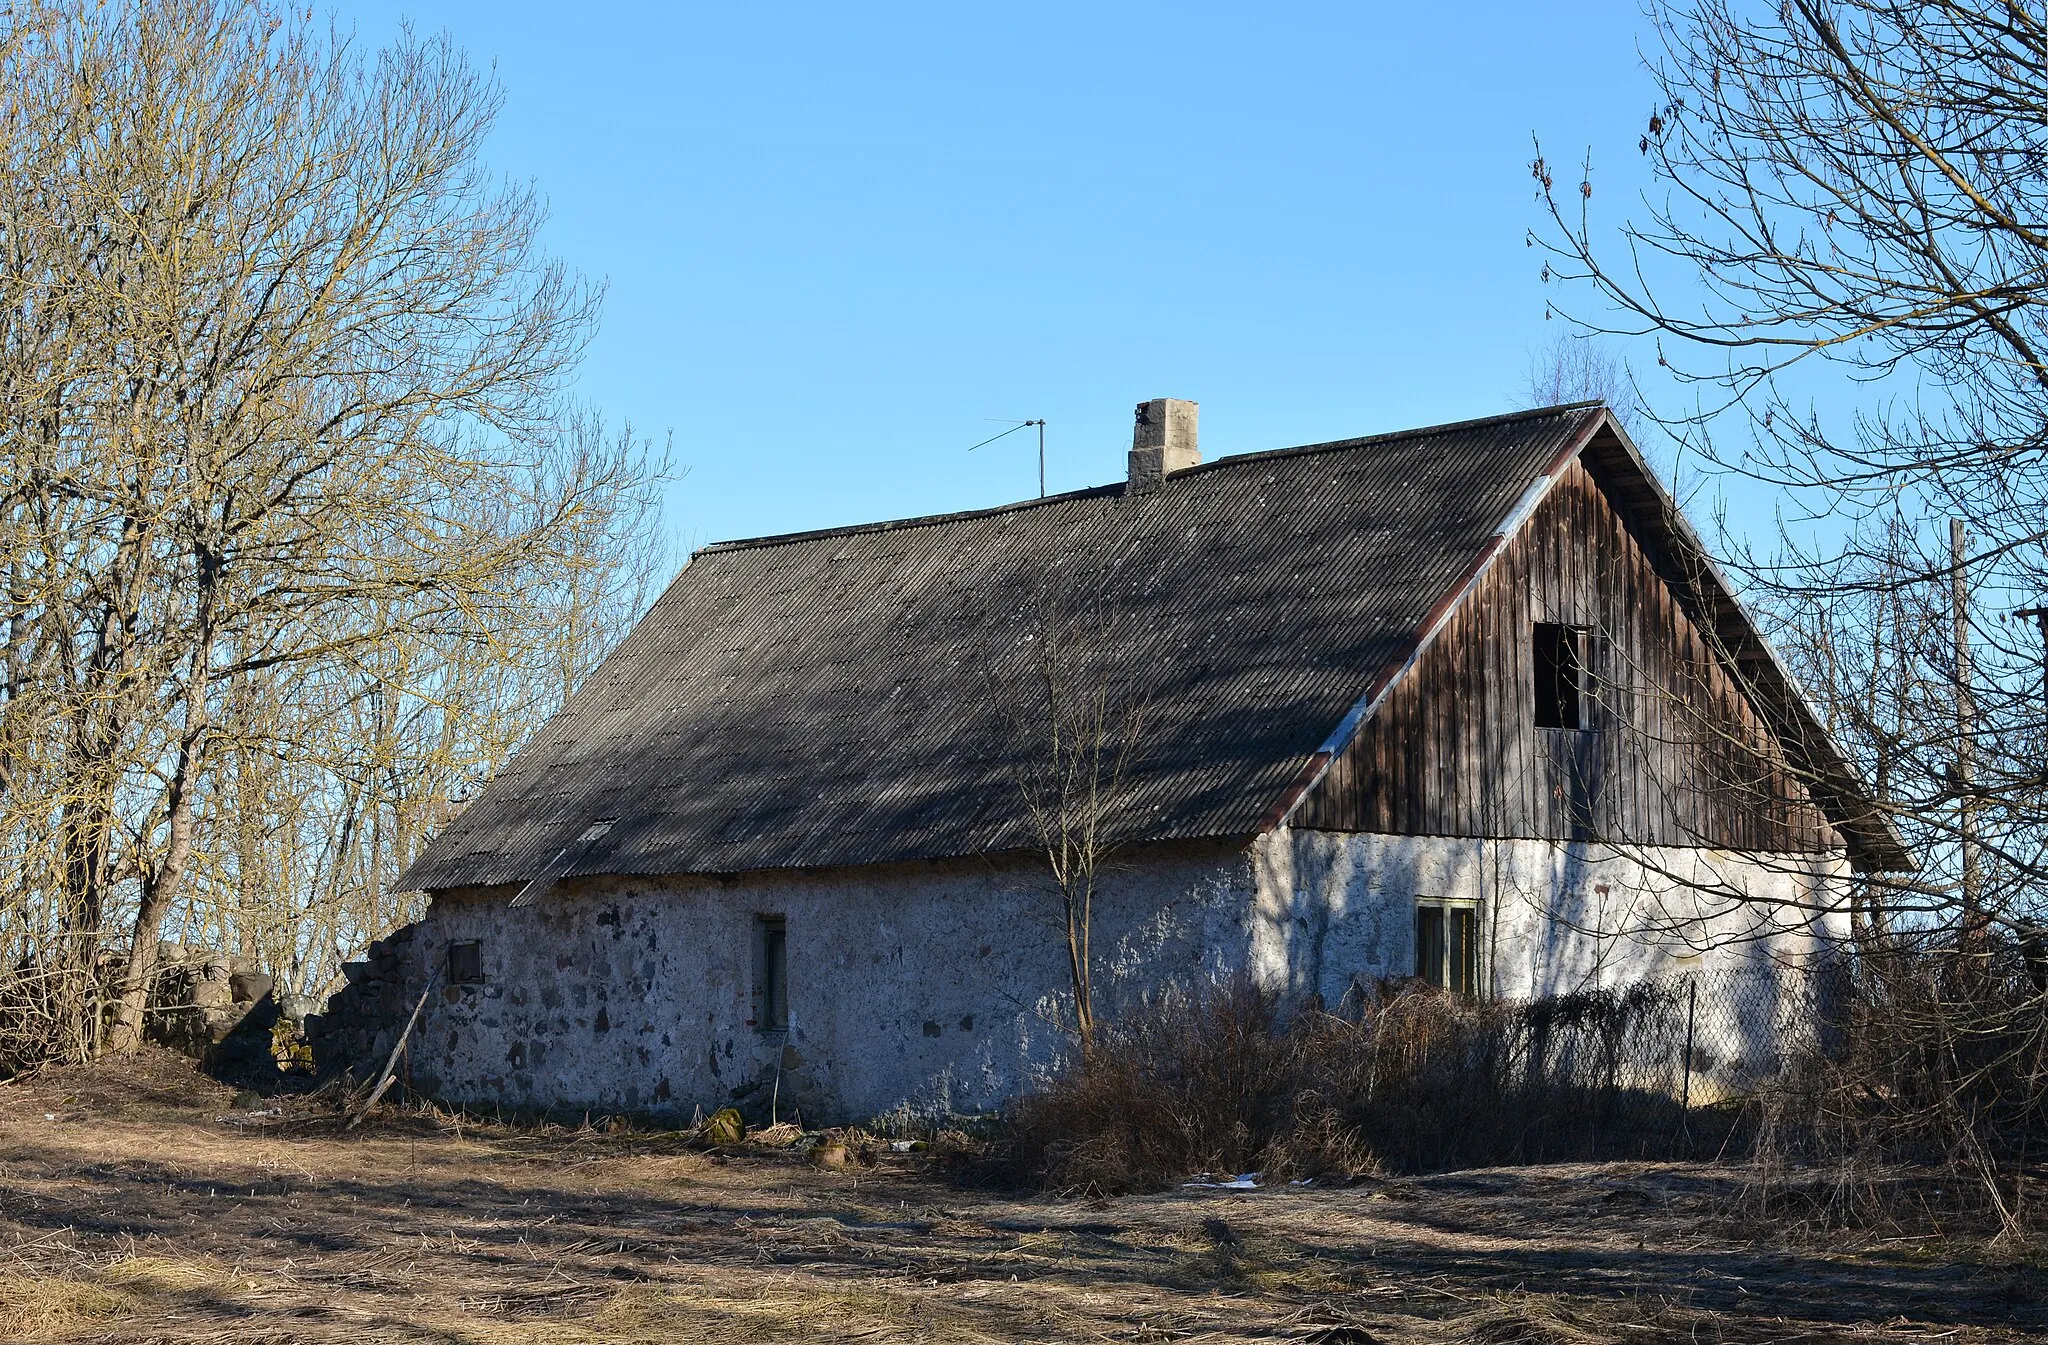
[[1532, 0, 2048, 1216]]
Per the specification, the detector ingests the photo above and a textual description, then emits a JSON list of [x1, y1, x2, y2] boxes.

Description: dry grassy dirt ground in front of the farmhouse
[[0, 1054, 2048, 1345]]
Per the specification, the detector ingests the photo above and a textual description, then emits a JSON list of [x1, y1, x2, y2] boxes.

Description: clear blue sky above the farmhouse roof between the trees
[[336, 0, 1679, 547]]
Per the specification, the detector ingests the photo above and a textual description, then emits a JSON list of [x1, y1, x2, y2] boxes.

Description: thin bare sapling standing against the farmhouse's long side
[[989, 571, 1151, 1058]]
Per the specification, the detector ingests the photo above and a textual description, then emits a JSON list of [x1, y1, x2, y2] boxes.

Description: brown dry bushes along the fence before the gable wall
[[1010, 981, 1698, 1191]]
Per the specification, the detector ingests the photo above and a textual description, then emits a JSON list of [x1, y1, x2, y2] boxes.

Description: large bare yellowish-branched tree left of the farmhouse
[[0, 0, 655, 1054]]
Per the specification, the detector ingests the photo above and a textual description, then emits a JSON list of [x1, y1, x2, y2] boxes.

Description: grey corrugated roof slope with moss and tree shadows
[[401, 405, 1608, 888]]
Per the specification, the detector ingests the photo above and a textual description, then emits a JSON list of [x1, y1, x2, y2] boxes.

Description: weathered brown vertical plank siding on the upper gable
[[1294, 463, 1841, 852]]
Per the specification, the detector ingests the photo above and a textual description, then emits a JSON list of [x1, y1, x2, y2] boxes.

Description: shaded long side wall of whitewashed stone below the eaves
[[397, 845, 1253, 1122]]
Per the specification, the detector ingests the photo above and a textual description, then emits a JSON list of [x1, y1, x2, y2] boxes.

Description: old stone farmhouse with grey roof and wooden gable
[[344, 399, 1911, 1122]]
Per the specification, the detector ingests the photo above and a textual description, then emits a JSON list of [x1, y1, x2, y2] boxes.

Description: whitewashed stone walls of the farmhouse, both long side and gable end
[[395, 831, 1845, 1122]]
